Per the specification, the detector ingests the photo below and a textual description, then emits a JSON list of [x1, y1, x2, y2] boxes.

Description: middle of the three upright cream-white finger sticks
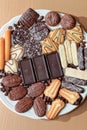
[[64, 39, 73, 64]]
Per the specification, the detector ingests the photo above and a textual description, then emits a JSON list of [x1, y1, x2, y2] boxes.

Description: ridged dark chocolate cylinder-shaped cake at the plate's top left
[[18, 8, 39, 28]]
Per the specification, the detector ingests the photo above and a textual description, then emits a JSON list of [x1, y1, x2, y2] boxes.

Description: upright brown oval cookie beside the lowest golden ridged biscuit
[[33, 97, 46, 117]]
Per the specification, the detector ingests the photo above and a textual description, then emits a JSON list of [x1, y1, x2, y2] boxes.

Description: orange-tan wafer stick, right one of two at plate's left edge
[[5, 29, 11, 61]]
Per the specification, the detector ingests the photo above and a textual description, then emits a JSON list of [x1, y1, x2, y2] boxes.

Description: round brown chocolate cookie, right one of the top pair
[[60, 14, 76, 30]]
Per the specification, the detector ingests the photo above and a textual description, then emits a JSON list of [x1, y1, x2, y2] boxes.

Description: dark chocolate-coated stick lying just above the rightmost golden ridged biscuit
[[61, 81, 84, 93]]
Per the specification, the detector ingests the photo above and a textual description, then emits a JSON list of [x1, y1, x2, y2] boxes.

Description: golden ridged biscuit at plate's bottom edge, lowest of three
[[46, 99, 65, 120]]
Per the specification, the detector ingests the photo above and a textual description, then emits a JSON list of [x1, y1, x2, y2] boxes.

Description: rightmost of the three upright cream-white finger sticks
[[71, 41, 78, 66]]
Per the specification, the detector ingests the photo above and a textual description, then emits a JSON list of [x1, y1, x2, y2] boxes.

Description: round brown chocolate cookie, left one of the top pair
[[45, 11, 60, 26]]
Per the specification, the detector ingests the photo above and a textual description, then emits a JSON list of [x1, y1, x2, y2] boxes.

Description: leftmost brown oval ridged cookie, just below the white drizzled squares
[[2, 74, 22, 87]]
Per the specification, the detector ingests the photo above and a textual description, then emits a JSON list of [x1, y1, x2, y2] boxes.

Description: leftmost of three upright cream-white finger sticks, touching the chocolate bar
[[59, 44, 68, 68]]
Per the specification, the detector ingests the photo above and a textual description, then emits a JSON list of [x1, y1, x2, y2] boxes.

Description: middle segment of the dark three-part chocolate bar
[[32, 55, 49, 82]]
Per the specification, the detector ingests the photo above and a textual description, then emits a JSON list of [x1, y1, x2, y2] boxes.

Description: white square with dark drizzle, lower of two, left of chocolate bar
[[4, 60, 18, 74]]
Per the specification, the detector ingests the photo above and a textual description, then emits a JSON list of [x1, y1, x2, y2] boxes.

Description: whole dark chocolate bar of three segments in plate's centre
[[20, 52, 63, 85]]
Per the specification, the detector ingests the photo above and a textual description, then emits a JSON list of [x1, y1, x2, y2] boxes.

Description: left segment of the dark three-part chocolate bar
[[20, 59, 36, 85]]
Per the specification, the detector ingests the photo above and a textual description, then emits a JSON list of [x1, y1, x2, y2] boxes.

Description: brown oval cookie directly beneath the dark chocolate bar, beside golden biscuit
[[28, 82, 45, 98]]
